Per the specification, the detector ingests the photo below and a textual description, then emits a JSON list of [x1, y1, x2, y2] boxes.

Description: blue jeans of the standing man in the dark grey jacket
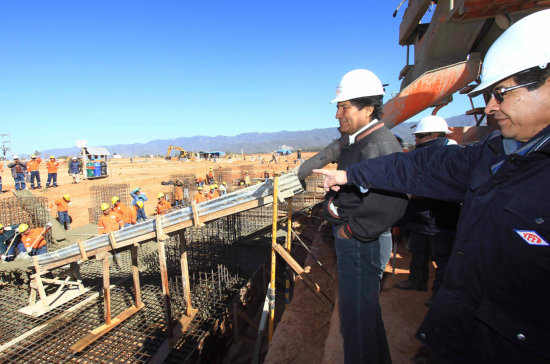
[[334, 232, 392, 364]]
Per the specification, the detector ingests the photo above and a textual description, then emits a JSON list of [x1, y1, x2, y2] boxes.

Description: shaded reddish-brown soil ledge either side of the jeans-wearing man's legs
[[265, 229, 434, 364]]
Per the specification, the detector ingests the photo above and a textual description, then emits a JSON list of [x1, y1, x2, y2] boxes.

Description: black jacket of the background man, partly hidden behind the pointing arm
[[404, 137, 460, 236]]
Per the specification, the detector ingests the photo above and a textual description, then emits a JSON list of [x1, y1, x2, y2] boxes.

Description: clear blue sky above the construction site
[[0, 0, 476, 154]]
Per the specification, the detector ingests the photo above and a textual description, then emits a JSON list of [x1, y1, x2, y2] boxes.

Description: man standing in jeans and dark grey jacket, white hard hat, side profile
[[324, 69, 407, 363]]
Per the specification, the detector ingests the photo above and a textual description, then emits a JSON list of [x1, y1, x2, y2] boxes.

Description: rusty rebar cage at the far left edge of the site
[[0, 196, 52, 248]]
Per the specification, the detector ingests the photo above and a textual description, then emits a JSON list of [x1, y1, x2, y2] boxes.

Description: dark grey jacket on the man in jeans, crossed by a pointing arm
[[324, 125, 407, 242]]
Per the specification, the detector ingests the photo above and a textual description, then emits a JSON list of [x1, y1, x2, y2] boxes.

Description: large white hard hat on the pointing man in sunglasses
[[469, 9, 550, 96]]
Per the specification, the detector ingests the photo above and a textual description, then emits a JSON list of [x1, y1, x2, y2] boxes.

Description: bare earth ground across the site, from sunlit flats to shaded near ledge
[[0, 153, 433, 364]]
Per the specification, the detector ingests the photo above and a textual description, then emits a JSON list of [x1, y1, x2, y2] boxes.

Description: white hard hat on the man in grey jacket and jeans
[[331, 69, 384, 103]]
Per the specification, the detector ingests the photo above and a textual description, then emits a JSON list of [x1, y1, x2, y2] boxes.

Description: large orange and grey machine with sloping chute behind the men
[[297, 0, 550, 179]]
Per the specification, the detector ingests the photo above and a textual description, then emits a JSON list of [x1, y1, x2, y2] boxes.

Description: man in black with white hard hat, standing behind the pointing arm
[[395, 115, 460, 306]]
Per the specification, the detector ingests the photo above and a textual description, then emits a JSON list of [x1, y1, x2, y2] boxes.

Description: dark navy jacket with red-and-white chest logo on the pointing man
[[347, 127, 550, 363]]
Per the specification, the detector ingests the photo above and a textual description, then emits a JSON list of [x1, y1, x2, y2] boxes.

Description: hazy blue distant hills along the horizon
[[41, 115, 475, 157]]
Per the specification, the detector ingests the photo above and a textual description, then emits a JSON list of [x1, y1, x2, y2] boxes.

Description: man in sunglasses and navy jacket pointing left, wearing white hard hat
[[316, 10, 550, 363]]
